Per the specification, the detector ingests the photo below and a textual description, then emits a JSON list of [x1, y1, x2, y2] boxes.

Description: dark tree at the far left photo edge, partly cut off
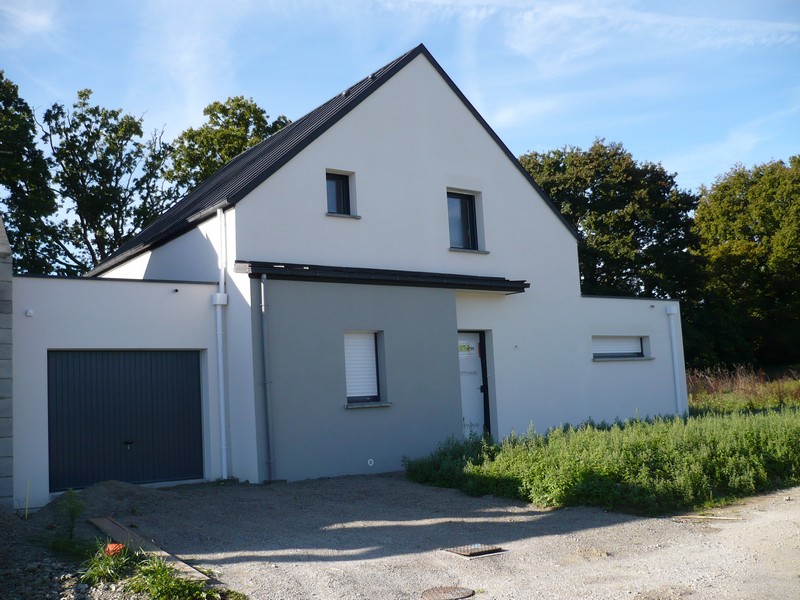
[[0, 71, 57, 273]]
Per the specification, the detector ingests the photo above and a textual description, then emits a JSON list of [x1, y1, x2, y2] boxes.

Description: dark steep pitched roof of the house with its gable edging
[[89, 44, 577, 276]]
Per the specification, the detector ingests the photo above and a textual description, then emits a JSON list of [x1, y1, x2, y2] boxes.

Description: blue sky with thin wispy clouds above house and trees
[[0, 0, 800, 190]]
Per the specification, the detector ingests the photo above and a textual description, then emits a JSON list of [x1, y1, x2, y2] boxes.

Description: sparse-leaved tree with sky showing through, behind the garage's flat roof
[[42, 90, 177, 275]]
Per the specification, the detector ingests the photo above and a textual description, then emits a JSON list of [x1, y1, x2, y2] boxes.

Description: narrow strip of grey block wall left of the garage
[[0, 222, 14, 508]]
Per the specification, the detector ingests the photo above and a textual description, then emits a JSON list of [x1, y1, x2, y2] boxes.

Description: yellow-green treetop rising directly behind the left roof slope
[[168, 96, 290, 189]]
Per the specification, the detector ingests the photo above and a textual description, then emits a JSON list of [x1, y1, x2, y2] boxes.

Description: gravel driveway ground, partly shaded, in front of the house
[[0, 474, 800, 600]]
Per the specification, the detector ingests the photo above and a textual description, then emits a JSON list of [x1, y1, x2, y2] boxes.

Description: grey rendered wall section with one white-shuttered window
[[267, 281, 462, 479]]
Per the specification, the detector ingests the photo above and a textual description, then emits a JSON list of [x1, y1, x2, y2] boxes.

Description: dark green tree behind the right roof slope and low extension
[[520, 139, 697, 298]]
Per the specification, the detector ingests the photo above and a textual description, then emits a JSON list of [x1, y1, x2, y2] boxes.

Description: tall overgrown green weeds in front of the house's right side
[[405, 373, 800, 515]]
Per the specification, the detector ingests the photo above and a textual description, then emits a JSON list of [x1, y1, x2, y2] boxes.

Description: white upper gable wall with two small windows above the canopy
[[231, 56, 578, 288]]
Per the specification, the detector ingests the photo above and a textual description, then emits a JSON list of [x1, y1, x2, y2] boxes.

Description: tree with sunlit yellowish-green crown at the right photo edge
[[695, 156, 800, 364]]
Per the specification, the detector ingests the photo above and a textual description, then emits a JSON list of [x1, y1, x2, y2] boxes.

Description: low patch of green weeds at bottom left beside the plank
[[81, 541, 245, 600]]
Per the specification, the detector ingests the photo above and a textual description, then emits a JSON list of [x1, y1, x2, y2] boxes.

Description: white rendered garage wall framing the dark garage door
[[13, 277, 220, 507]]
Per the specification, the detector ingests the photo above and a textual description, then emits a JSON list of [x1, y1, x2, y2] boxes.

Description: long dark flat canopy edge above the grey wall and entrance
[[234, 260, 531, 294]]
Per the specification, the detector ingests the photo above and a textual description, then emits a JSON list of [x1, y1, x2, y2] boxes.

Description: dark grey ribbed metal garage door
[[47, 350, 203, 491]]
